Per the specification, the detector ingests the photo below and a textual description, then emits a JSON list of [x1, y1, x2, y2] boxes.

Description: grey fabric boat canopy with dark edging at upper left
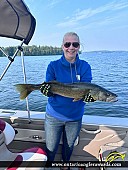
[[0, 0, 36, 45]]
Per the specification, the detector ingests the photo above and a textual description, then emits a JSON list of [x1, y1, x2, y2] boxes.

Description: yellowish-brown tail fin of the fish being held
[[15, 84, 33, 100]]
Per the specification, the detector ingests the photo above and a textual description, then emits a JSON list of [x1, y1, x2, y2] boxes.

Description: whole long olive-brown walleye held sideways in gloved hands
[[15, 81, 117, 102]]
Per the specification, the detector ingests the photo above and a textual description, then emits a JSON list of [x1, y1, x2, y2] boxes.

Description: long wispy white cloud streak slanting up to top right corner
[[57, 1, 128, 27]]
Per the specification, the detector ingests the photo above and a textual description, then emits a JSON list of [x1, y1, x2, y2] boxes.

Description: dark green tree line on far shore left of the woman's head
[[0, 45, 62, 57]]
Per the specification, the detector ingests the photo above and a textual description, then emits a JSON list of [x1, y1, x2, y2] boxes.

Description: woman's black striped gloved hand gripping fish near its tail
[[40, 83, 54, 97]]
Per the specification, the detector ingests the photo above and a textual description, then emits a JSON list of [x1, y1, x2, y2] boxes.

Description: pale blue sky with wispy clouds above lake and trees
[[0, 0, 128, 51]]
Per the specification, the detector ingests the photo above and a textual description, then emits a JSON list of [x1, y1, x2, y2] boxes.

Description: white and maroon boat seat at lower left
[[0, 119, 47, 170]]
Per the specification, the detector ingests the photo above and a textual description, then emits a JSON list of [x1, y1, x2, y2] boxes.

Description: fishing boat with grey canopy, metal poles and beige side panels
[[0, 0, 128, 170]]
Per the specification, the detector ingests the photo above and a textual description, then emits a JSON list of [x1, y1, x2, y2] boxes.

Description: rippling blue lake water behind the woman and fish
[[0, 51, 128, 117]]
